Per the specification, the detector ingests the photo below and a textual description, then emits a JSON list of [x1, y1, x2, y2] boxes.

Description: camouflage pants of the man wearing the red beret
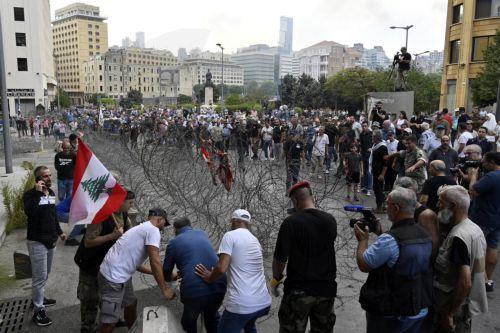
[[278, 292, 336, 333]]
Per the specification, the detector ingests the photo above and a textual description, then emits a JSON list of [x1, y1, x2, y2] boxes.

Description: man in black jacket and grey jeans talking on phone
[[23, 165, 66, 326]]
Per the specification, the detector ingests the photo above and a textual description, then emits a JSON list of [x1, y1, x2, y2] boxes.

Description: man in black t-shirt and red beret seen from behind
[[271, 181, 337, 332]]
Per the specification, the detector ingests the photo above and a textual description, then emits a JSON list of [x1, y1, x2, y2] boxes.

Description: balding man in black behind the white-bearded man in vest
[[420, 160, 457, 213]]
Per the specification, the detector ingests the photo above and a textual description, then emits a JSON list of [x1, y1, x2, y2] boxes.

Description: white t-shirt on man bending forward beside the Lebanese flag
[[100, 221, 161, 283]]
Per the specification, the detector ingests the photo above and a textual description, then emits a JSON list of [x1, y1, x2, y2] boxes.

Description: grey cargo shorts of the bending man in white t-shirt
[[97, 272, 137, 324]]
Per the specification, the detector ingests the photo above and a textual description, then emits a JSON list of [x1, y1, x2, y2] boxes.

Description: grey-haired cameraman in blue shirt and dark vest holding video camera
[[354, 187, 432, 333]]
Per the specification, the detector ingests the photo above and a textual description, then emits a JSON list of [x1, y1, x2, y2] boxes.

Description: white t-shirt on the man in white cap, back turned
[[218, 228, 271, 314]]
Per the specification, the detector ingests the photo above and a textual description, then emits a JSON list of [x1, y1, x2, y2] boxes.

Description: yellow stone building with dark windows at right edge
[[439, 0, 500, 110]]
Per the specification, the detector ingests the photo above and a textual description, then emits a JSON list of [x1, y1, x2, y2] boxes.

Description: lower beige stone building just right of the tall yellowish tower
[[83, 47, 177, 99]]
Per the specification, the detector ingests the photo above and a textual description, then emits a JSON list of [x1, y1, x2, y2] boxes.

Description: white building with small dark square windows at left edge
[[0, 0, 57, 116]]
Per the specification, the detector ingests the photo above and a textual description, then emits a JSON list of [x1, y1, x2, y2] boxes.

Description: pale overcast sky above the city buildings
[[50, 0, 447, 57]]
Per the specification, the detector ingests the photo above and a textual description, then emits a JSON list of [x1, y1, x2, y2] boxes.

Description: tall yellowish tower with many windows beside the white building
[[52, 3, 108, 104]]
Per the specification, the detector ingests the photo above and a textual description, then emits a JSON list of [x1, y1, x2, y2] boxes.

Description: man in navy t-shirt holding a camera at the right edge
[[469, 152, 500, 292]]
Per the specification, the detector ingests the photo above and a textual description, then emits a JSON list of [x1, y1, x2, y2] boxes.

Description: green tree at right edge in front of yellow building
[[471, 30, 500, 106]]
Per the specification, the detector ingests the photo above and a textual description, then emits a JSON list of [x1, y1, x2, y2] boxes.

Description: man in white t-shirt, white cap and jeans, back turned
[[196, 209, 271, 333]]
